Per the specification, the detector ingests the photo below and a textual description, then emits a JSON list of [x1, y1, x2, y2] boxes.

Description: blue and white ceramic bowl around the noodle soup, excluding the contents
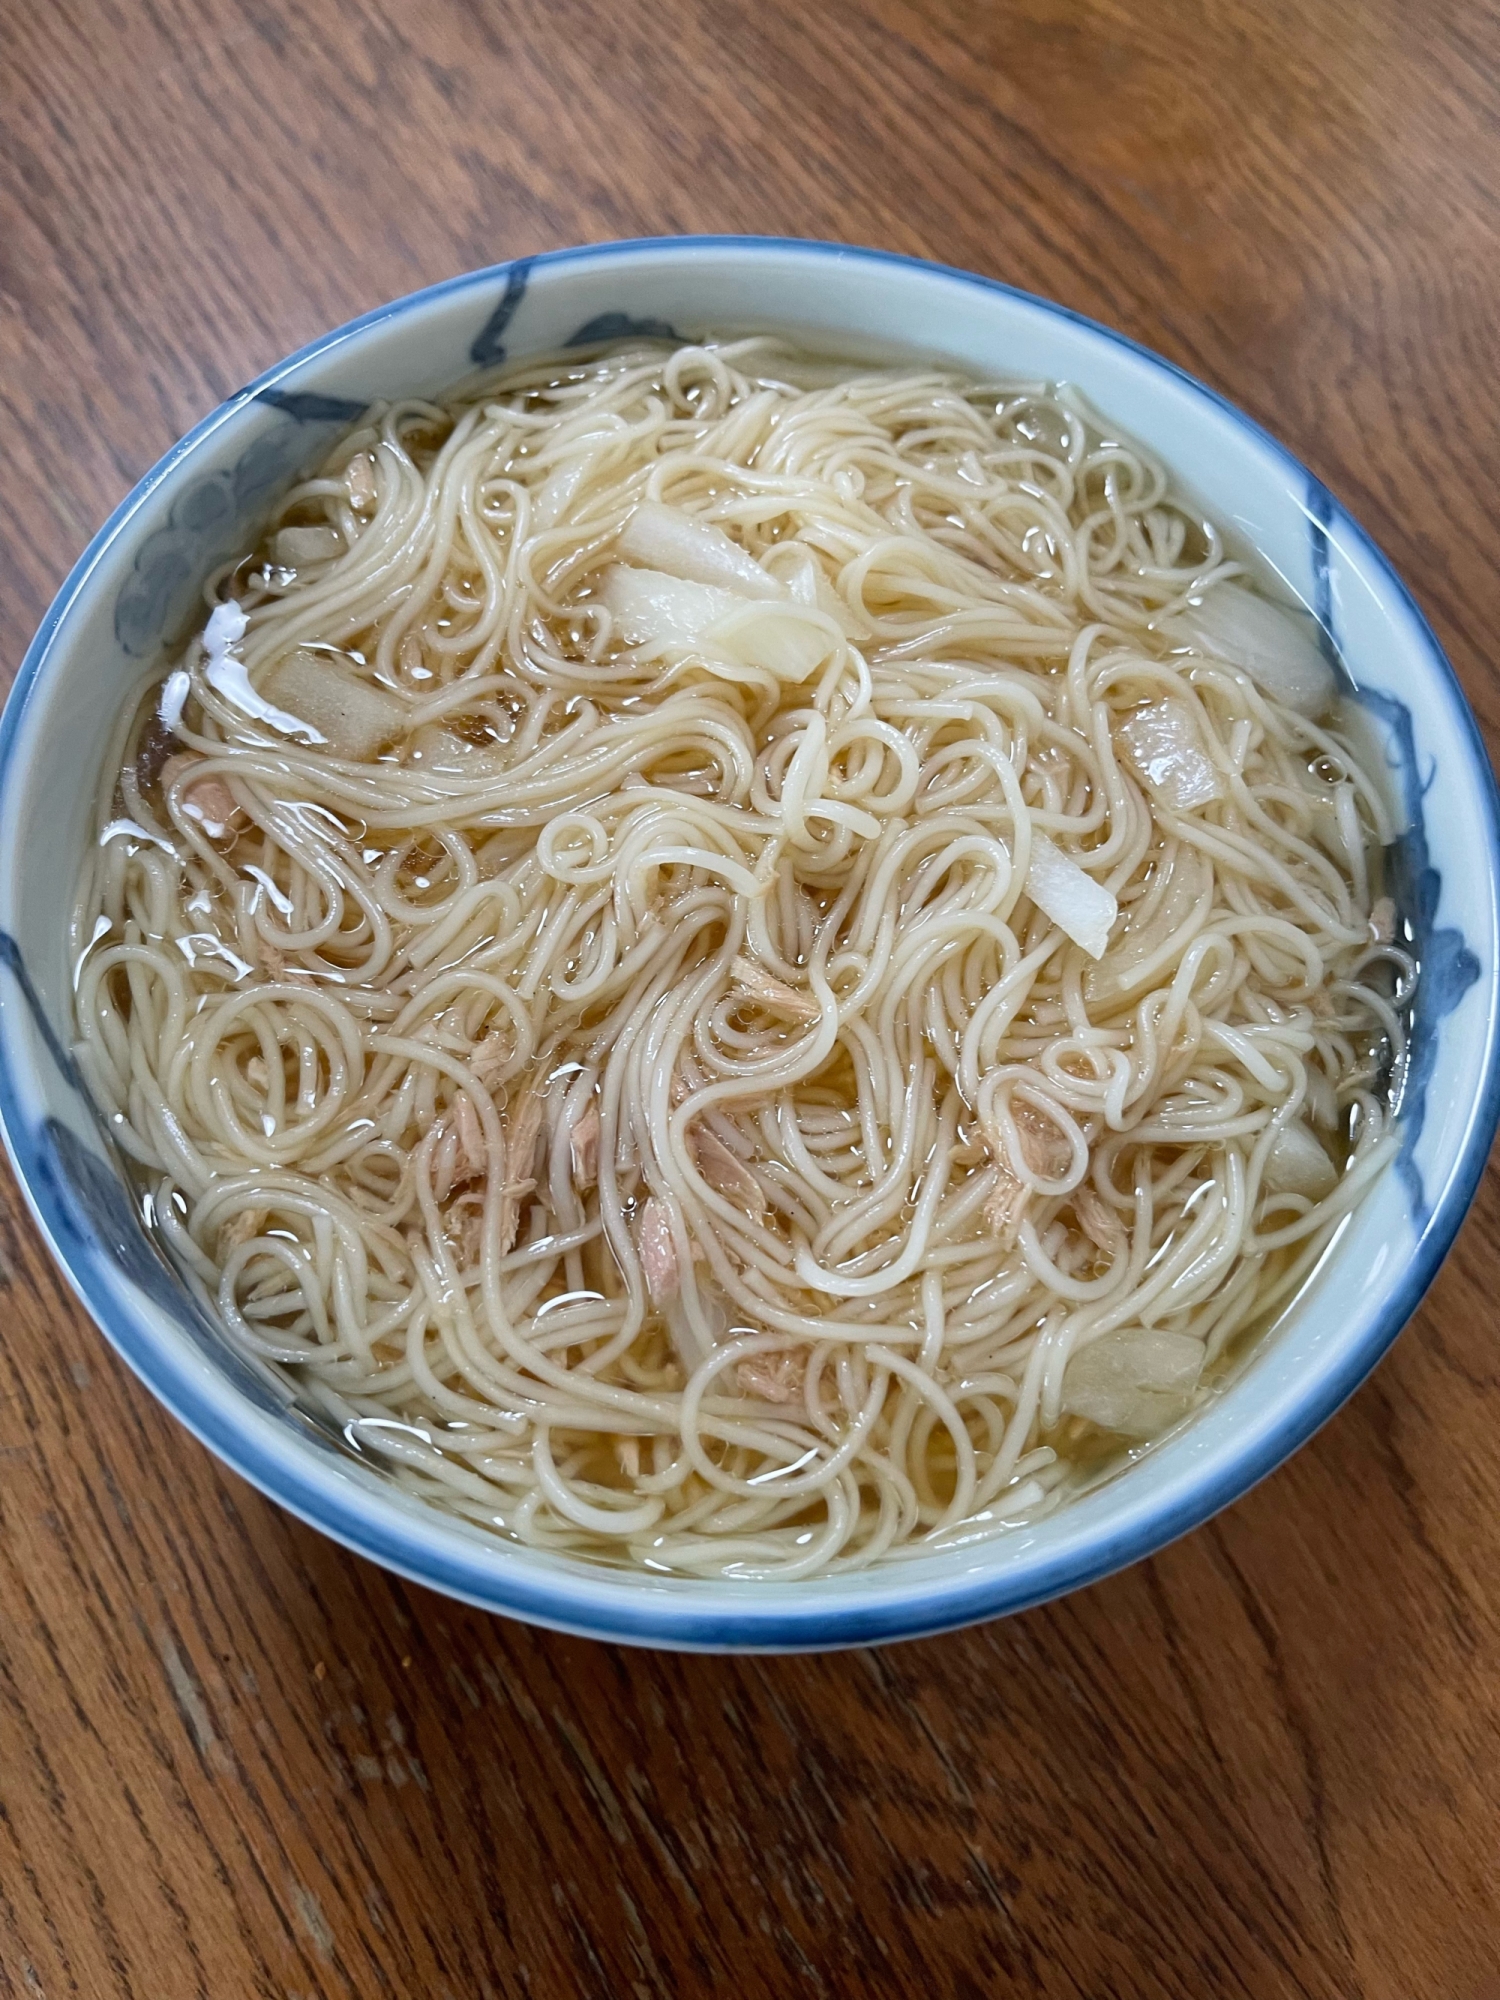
[[0, 236, 1500, 1650]]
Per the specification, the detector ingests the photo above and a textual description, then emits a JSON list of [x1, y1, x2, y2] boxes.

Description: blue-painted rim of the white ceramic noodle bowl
[[0, 236, 1500, 1652]]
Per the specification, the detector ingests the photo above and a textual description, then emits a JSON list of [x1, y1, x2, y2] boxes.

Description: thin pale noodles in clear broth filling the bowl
[[74, 340, 1416, 1578]]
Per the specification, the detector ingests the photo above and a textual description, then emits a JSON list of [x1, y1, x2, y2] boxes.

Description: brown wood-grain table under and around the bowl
[[0, 0, 1500, 2000]]
